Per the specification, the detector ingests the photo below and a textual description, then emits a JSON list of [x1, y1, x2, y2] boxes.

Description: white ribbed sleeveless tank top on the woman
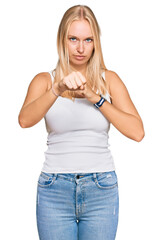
[[42, 71, 115, 173]]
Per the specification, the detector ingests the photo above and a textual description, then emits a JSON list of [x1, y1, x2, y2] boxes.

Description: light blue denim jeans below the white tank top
[[36, 171, 119, 240]]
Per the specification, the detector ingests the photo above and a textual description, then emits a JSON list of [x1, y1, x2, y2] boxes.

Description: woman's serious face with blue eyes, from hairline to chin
[[67, 20, 94, 69]]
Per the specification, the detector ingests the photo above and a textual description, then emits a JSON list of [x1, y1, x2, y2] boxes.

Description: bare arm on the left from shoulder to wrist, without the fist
[[18, 72, 60, 128]]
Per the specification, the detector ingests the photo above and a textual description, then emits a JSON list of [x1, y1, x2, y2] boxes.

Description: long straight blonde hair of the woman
[[53, 5, 108, 99]]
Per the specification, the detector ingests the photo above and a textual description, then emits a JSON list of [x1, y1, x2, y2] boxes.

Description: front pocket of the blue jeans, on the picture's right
[[95, 171, 118, 189]]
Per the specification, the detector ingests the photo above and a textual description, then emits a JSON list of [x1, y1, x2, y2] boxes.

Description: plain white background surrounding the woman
[[0, 0, 163, 240]]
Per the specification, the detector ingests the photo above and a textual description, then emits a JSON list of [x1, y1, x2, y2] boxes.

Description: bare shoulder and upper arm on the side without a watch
[[22, 72, 52, 107]]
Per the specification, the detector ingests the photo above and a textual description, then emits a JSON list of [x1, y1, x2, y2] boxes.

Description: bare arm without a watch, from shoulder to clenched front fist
[[18, 72, 86, 128]]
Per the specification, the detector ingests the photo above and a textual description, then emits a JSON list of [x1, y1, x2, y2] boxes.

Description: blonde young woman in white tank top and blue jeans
[[19, 5, 144, 240]]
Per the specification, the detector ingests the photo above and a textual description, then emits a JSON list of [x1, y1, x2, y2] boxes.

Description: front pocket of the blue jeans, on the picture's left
[[37, 172, 55, 188]]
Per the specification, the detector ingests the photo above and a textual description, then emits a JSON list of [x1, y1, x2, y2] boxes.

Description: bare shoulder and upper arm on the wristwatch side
[[105, 70, 141, 120]]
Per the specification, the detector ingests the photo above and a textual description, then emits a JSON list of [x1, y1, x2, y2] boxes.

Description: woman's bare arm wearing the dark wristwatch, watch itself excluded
[[89, 71, 144, 142]]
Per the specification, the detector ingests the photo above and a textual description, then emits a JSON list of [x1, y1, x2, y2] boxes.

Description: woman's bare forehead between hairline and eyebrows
[[68, 20, 93, 38]]
